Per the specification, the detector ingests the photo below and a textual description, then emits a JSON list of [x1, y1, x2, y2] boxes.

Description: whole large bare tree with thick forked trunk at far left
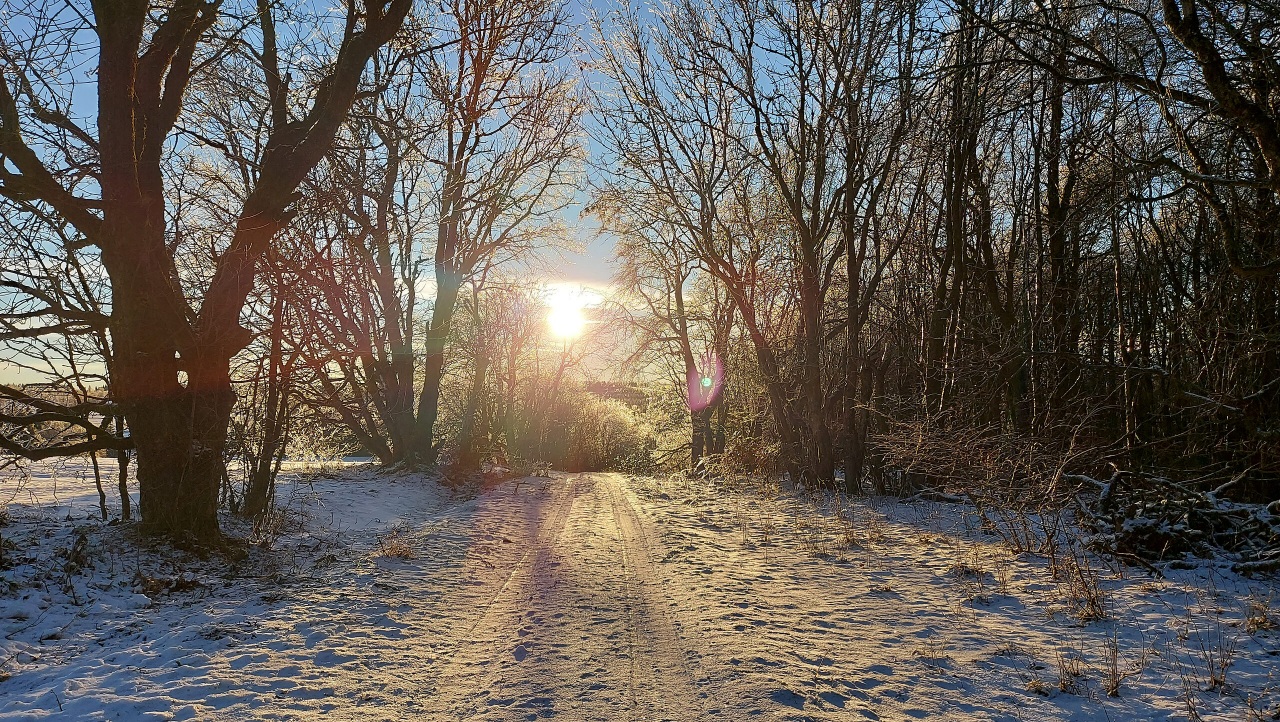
[[0, 0, 410, 540]]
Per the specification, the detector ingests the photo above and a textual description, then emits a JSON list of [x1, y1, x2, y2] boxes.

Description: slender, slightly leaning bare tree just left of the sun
[[404, 0, 582, 463]]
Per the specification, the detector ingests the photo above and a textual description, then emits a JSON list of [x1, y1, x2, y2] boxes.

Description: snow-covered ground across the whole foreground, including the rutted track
[[0, 462, 1280, 721]]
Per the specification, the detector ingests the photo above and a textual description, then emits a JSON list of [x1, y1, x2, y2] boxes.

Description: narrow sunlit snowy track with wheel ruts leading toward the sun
[[431, 474, 707, 722]]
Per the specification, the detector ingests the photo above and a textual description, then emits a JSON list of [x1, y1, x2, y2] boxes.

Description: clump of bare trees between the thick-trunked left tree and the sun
[[285, 0, 582, 467]]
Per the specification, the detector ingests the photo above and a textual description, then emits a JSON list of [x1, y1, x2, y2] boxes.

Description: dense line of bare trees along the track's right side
[[594, 0, 1280, 503]]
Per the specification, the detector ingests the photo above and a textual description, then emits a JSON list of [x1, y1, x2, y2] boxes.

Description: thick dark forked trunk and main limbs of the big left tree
[[0, 0, 411, 543]]
